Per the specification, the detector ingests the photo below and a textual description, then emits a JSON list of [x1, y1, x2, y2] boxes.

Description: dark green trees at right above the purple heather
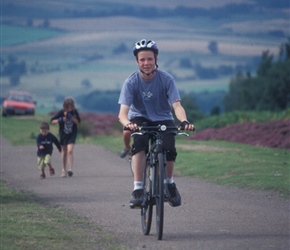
[[223, 38, 290, 112]]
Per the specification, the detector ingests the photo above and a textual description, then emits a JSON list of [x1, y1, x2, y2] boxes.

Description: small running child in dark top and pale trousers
[[36, 122, 61, 179]]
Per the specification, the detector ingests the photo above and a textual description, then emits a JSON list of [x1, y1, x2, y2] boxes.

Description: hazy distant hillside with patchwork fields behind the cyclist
[[1, 0, 289, 112]]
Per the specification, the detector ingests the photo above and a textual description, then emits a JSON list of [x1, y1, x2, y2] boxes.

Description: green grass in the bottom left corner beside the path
[[0, 182, 125, 250]]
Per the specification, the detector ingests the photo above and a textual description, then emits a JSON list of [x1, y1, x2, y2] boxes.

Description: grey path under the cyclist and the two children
[[0, 137, 290, 250]]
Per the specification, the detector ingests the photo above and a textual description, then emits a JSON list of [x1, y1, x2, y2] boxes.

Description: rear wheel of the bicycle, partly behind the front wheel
[[141, 166, 153, 235]]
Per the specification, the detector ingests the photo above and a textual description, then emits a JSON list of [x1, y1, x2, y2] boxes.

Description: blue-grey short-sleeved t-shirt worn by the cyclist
[[118, 70, 180, 121]]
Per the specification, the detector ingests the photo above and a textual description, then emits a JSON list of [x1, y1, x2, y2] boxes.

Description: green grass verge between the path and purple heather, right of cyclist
[[176, 141, 290, 198]]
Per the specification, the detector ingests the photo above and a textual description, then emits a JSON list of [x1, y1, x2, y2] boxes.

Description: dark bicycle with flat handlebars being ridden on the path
[[132, 123, 193, 240]]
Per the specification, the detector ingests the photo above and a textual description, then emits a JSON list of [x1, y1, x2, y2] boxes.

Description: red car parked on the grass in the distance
[[2, 91, 36, 116]]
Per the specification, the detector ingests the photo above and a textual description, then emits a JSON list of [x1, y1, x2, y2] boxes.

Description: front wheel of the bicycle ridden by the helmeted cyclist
[[156, 153, 165, 240]]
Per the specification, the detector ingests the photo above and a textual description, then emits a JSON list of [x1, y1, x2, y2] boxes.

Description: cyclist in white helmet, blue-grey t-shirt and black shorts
[[118, 39, 194, 208]]
